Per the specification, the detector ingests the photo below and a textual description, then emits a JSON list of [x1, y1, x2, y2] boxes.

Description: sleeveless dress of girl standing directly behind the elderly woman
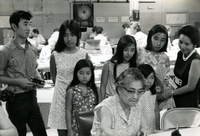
[[106, 61, 129, 98]]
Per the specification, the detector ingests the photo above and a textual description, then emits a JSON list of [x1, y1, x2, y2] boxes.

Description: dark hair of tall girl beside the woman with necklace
[[145, 24, 168, 52]]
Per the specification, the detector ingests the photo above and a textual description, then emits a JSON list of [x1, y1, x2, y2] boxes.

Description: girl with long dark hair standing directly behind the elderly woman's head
[[100, 35, 137, 100]]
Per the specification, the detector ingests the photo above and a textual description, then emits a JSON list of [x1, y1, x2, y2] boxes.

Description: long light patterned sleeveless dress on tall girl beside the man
[[48, 48, 87, 129]]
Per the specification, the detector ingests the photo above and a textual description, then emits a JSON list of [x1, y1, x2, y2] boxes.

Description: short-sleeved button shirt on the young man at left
[[0, 39, 38, 94]]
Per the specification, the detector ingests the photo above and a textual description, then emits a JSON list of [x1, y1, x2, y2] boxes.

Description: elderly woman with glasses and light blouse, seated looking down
[[91, 68, 150, 136]]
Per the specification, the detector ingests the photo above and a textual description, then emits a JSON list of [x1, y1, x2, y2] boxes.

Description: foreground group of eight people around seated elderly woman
[[0, 11, 200, 136]]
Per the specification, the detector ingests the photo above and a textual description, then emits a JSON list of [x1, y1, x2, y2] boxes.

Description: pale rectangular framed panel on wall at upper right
[[165, 12, 188, 26]]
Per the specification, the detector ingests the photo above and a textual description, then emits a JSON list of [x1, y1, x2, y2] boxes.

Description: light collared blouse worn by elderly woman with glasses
[[91, 95, 141, 136]]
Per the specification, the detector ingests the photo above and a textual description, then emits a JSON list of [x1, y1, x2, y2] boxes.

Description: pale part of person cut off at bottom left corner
[[0, 101, 18, 136]]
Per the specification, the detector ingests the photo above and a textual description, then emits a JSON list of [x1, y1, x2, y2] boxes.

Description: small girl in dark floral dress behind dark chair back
[[66, 59, 98, 136]]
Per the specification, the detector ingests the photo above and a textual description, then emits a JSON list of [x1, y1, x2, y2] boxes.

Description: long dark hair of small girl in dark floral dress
[[67, 59, 98, 102]]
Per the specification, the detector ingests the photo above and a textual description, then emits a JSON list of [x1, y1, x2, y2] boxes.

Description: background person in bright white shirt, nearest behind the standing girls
[[130, 21, 147, 48]]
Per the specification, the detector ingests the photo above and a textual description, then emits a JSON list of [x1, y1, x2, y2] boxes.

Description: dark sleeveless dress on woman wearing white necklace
[[174, 51, 200, 107]]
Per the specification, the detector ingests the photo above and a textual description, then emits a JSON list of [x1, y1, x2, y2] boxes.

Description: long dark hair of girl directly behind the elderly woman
[[110, 35, 137, 79]]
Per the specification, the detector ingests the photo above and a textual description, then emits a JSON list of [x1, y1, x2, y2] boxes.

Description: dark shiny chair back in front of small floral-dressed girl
[[75, 111, 94, 136]]
